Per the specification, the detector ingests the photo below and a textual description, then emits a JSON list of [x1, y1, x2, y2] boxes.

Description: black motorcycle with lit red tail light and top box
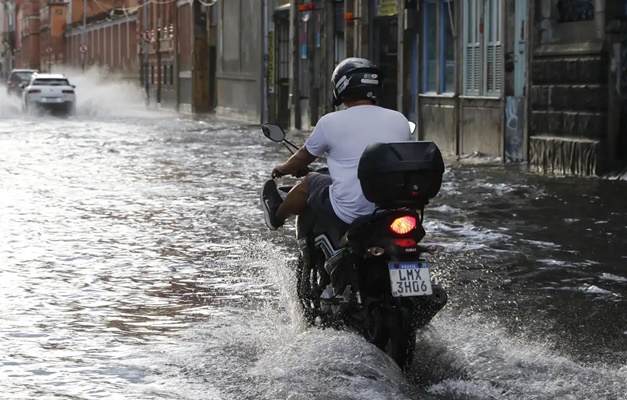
[[262, 122, 447, 371]]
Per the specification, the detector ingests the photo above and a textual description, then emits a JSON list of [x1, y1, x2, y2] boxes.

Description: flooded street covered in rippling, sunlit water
[[0, 86, 627, 400]]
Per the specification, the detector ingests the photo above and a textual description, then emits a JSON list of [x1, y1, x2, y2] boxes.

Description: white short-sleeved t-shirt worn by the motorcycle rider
[[305, 105, 411, 224]]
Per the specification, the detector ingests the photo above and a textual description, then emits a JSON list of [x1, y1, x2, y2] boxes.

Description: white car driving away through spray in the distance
[[21, 73, 76, 115]]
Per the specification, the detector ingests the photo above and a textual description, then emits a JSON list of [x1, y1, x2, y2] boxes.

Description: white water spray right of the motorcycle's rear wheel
[[417, 315, 627, 400]]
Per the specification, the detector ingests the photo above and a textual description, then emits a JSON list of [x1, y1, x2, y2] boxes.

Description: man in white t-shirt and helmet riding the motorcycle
[[261, 58, 411, 230]]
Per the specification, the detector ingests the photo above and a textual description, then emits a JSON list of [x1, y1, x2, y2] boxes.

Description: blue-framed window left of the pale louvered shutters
[[422, 0, 455, 93]]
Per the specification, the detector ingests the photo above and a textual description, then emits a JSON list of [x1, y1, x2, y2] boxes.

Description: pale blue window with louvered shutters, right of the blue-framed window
[[464, 0, 503, 96]]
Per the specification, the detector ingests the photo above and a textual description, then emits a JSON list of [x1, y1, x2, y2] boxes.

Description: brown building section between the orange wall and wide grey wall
[[137, 0, 217, 113]]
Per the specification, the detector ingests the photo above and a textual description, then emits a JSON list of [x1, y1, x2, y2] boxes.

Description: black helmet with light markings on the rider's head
[[331, 58, 383, 107]]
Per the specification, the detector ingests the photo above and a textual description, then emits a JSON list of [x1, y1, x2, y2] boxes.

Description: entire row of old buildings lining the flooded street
[[3, 0, 627, 175]]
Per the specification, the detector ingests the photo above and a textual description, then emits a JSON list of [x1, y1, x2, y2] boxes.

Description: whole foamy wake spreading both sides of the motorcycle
[[114, 242, 627, 400]]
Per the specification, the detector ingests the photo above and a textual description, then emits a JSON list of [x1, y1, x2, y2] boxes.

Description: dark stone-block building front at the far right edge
[[527, 0, 627, 175]]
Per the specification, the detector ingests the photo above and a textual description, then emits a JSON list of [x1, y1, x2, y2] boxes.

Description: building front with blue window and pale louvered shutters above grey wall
[[404, 0, 526, 161]]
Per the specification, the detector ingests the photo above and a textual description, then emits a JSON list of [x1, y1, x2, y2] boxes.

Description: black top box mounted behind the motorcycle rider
[[357, 141, 444, 209]]
